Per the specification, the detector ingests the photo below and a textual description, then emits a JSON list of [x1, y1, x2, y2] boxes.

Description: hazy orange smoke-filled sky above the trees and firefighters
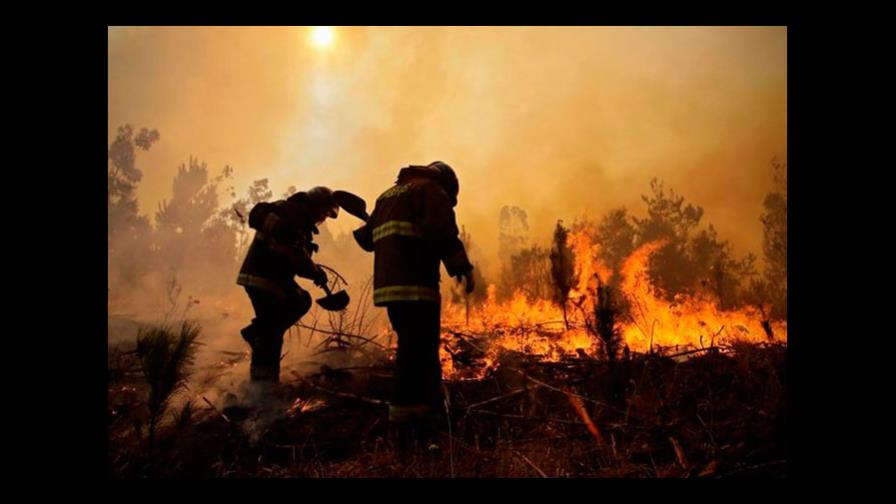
[[109, 27, 787, 266]]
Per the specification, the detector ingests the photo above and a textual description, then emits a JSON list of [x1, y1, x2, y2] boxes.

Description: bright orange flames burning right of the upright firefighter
[[441, 230, 787, 379]]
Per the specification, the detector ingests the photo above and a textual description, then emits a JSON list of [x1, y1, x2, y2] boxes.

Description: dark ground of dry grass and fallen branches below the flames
[[109, 338, 786, 478]]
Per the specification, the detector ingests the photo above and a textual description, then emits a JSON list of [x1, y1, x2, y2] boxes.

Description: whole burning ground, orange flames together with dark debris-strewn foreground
[[109, 222, 787, 478]]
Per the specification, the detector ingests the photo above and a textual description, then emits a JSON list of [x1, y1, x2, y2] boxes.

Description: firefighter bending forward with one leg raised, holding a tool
[[236, 187, 367, 383]]
